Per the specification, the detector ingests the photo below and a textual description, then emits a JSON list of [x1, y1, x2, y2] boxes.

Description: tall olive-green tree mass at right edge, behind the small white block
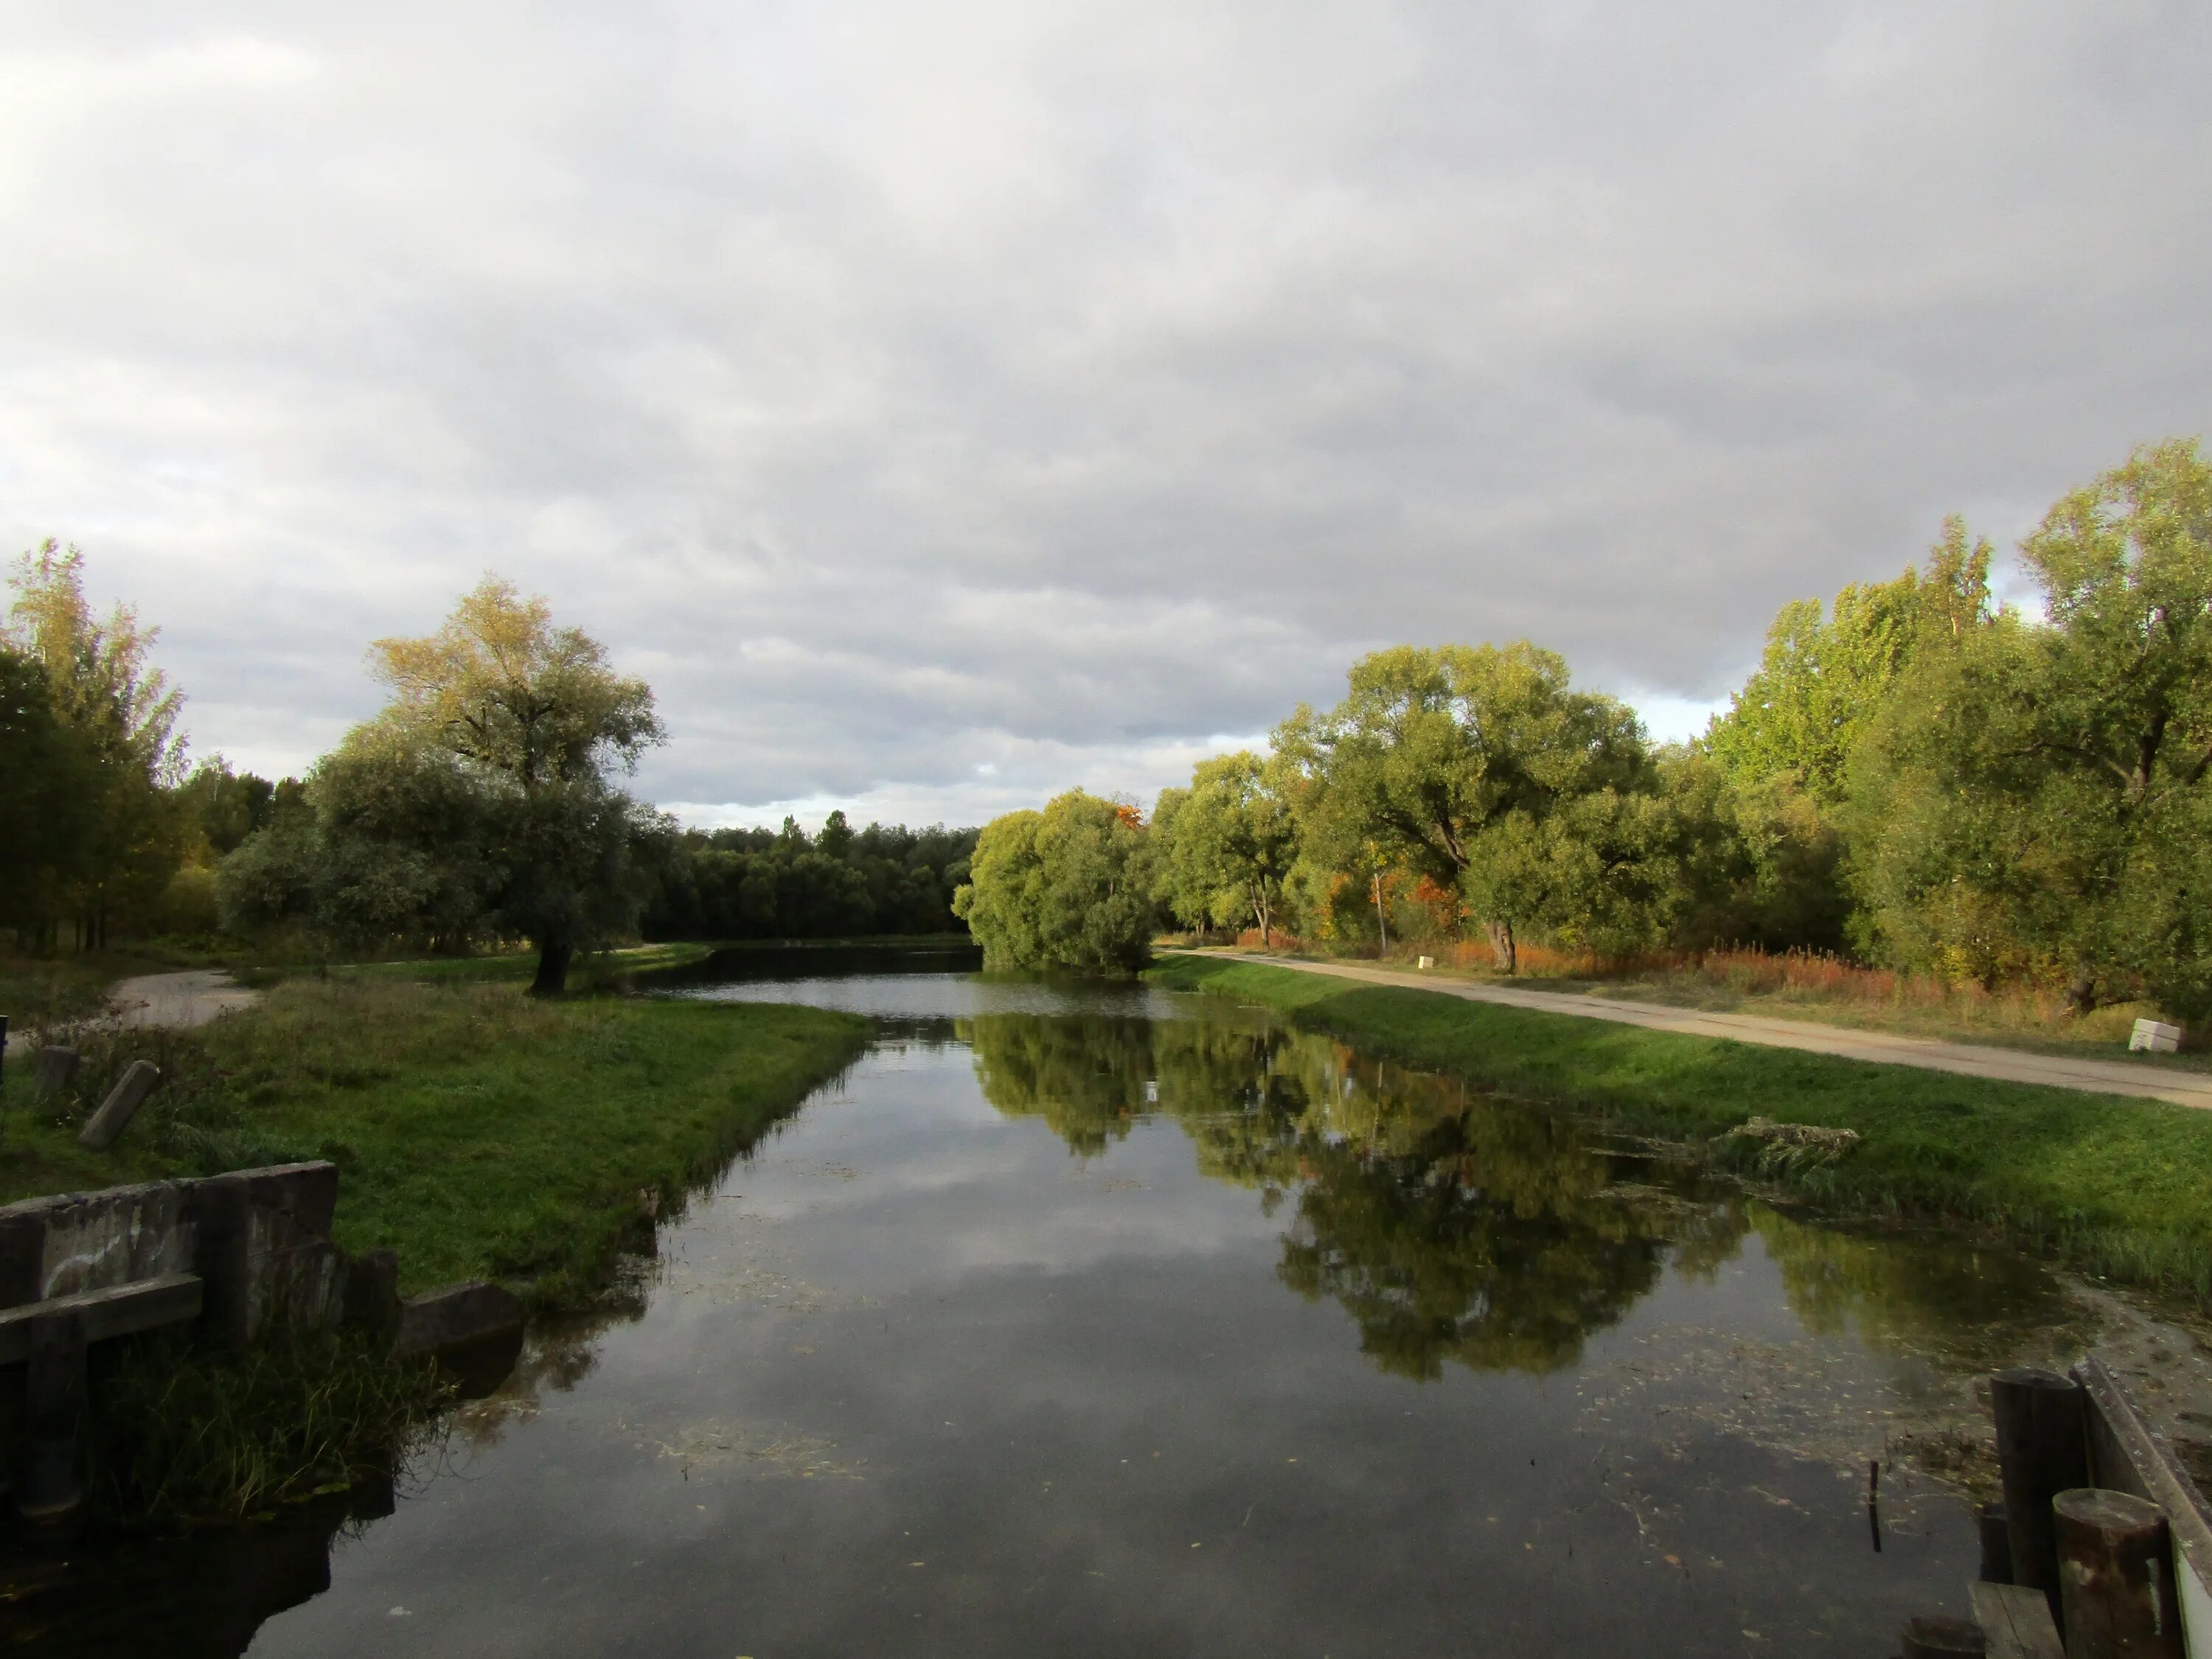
[[1851, 442, 2212, 1020]]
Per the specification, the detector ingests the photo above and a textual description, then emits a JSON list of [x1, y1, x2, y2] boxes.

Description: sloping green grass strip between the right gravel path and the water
[[1148, 958, 2212, 1301]]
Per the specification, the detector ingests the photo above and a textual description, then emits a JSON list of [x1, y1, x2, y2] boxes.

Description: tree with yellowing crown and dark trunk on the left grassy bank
[[367, 575, 666, 995]]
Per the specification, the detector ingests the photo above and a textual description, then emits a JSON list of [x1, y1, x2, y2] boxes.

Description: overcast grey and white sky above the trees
[[0, 0, 2212, 823]]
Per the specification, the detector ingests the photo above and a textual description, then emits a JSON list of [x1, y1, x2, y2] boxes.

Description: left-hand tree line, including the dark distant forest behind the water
[[0, 566, 975, 991]]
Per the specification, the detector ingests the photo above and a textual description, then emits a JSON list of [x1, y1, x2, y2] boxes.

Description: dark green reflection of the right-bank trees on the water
[[962, 1015, 1741, 1378]]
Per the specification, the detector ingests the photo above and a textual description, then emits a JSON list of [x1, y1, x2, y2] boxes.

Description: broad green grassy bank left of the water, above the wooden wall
[[0, 978, 867, 1307]]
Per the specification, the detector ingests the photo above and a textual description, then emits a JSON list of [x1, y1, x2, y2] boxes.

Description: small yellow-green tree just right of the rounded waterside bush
[[1152, 750, 1298, 945]]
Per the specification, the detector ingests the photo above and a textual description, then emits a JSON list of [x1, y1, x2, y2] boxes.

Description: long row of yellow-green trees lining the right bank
[[956, 440, 2212, 1018]]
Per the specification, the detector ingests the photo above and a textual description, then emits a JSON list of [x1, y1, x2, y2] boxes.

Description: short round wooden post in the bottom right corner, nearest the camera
[[2051, 1486, 2181, 1659]]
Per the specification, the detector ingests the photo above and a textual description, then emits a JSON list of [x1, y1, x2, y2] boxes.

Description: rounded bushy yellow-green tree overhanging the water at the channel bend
[[953, 790, 1157, 973]]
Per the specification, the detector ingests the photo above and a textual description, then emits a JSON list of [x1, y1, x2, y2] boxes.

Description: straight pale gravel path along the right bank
[[1188, 951, 2212, 1108]]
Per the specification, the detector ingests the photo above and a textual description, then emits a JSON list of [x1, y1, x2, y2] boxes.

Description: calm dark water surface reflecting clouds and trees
[[0, 953, 2141, 1659]]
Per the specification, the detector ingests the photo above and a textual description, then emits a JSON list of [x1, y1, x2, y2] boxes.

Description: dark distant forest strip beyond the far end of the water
[[644, 812, 978, 940]]
